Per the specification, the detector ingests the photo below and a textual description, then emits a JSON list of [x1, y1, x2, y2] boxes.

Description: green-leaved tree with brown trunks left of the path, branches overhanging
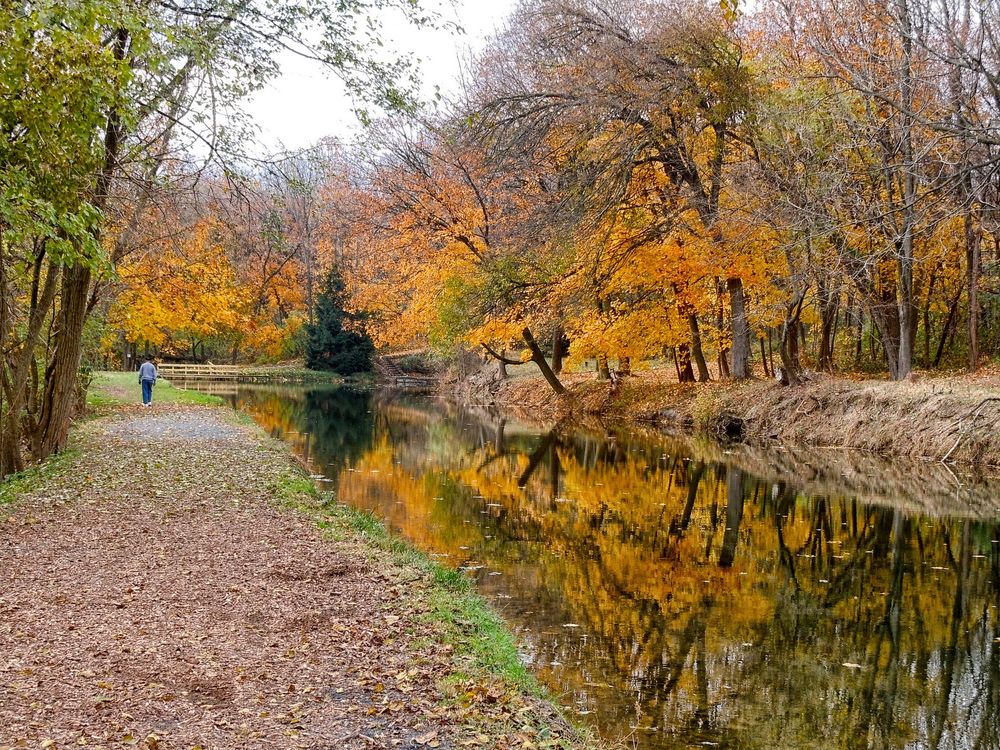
[[0, 0, 446, 476]]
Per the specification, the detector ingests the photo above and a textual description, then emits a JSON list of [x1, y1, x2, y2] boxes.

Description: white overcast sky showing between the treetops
[[246, 0, 516, 153]]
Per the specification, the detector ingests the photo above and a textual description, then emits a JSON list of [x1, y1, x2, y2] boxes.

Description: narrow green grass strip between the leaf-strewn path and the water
[[262, 462, 544, 696]]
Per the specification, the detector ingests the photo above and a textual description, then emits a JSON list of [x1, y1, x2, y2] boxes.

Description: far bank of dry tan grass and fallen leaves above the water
[[452, 373, 1000, 466]]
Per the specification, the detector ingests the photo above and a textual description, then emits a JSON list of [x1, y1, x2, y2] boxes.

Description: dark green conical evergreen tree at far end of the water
[[306, 268, 375, 375]]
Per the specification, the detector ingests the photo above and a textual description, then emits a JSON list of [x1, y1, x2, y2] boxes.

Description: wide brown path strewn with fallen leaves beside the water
[[0, 407, 582, 750]]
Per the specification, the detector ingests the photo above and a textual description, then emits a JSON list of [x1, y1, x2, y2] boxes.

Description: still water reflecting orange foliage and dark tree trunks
[[223, 388, 1000, 748]]
